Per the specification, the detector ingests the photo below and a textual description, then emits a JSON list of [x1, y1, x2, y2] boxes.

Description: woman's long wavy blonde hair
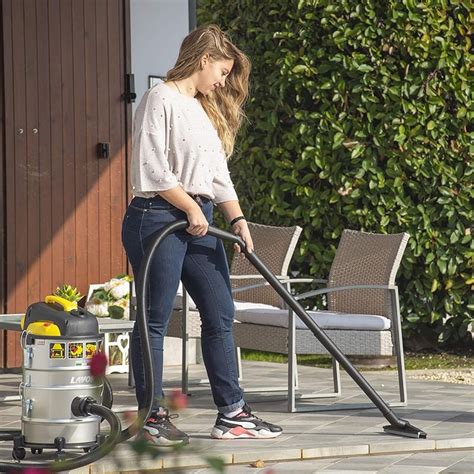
[[166, 25, 251, 158]]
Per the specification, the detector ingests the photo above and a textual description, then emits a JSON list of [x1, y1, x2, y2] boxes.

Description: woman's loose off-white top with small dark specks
[[131, 83, 238, 204]]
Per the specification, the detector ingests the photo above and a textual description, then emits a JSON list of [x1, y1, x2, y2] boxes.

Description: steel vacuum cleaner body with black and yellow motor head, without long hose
[[0, 295, 121, 471]]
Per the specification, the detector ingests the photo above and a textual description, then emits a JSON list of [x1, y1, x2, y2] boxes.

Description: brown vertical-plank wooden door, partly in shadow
[[0, 0, 131, 367]]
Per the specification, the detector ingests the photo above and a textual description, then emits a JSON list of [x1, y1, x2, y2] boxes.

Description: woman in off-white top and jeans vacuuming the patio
[[122, 25, 282, 445]]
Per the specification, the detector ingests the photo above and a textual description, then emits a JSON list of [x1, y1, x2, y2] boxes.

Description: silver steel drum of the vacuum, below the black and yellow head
[[20, 333, 103, 447]]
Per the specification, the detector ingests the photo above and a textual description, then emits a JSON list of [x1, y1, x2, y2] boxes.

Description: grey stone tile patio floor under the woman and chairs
[[0, 361, 474, 474]]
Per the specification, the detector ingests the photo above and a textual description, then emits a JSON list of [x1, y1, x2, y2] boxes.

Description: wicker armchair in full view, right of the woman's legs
[[234, 230, 409, 412]]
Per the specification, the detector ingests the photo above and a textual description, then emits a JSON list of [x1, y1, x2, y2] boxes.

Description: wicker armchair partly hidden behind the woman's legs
[[167, 222, 302, 393]]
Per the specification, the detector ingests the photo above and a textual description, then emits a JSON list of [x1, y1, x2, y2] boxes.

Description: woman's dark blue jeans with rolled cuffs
[[122, 196, 244, 412]]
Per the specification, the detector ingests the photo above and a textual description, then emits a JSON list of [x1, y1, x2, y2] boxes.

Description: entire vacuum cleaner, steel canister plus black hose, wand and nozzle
[[0, 220, 427, 471]]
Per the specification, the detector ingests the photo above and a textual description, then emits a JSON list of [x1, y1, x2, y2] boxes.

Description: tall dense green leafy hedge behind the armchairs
[[198, 0, 474, 343]]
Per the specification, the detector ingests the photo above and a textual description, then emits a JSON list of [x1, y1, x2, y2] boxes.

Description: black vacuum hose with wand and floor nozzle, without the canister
[[0, 220, 426, 471]]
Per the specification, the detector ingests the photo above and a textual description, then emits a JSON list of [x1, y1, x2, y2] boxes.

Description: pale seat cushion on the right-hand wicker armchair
[[235, 302, 390, 331]]
